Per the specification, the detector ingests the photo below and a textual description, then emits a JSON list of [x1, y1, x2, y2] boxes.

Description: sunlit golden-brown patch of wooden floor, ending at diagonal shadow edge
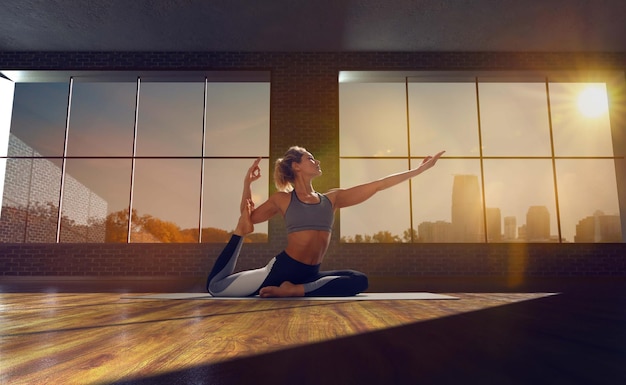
[[0, 293, 553, 383]]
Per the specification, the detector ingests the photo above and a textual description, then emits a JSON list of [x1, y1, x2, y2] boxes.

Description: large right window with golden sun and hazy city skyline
[[339, 71, 626, 242]]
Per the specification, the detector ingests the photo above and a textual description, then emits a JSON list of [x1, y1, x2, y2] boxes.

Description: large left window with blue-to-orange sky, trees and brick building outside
[[0, 71, 270, 243]]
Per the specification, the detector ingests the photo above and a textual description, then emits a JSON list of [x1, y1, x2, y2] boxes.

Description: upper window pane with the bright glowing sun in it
[[550, 83, 613, 156]]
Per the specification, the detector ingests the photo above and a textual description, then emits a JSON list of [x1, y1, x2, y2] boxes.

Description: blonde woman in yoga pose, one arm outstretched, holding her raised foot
[[207, 146, 444, 297]]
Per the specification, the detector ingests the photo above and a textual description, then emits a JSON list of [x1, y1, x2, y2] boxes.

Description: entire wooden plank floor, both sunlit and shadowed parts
[[0, 279, 626, 384]]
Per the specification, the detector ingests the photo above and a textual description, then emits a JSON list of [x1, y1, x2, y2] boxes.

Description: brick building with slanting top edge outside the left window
[[0, 134, 108, 243]]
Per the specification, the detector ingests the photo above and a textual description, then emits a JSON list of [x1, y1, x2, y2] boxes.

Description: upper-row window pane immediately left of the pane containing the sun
[[478, 83, 551, 156]]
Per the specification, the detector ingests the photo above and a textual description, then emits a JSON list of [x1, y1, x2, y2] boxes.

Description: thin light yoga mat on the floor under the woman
[[122, 292, 459, 301]]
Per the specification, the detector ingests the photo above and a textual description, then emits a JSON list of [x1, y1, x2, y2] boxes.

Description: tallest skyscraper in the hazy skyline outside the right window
[[452, 175, 485, 242]]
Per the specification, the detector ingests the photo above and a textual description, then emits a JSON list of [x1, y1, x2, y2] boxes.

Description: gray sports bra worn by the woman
[[285, 190, 335, 234]]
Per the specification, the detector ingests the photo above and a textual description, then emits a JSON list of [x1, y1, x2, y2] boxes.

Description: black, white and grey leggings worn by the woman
[[207, 235, 368, 297]]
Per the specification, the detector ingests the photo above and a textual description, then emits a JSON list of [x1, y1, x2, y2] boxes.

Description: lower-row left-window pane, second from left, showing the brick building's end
[[60, 159, 131, 243]]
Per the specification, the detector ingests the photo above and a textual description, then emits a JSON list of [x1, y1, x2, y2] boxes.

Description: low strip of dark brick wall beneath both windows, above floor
[[0, 243, 626, 280]]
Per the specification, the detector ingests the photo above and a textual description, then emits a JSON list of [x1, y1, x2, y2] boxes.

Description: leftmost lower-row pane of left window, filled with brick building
[[0, 159, 61, 243]]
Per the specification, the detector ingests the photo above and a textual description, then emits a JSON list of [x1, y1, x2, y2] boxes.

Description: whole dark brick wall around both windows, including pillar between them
[[0, 52, 626, 279]]
